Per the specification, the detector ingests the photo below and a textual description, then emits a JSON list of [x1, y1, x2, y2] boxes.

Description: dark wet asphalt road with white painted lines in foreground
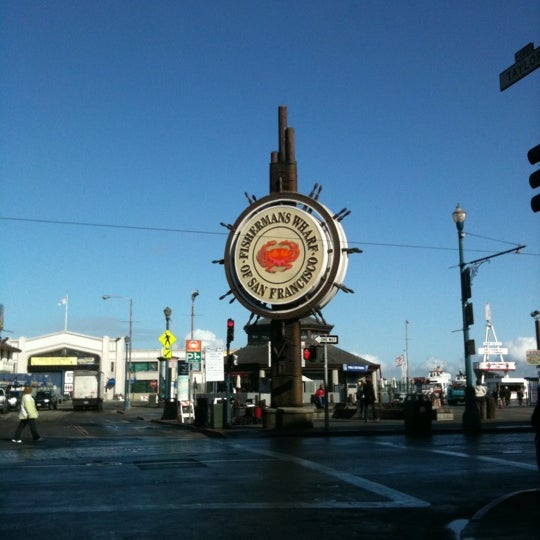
[[0, 403, 539, 540]]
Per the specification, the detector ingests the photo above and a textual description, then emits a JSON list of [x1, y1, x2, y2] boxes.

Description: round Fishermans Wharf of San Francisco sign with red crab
[[224, 192, 347, 319]]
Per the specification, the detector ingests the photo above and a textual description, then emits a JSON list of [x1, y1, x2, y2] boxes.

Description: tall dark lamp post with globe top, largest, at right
[[452, 204, 481, 433]]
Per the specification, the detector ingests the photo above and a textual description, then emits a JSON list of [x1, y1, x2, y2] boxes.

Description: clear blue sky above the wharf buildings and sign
[[0, 0, 540, 377]]
